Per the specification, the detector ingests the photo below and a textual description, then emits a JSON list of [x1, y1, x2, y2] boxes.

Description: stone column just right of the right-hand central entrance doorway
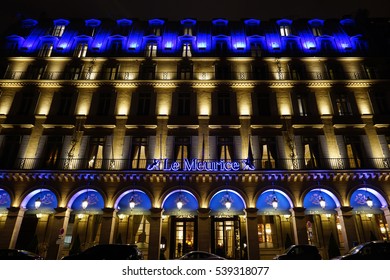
[[245, 208, 260, 260]]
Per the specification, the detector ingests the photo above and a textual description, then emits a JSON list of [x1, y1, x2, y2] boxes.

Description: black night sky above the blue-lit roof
[[0, 0, 390, 26]]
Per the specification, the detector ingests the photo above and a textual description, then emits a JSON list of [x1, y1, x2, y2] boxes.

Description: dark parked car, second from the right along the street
[[274, 244, 322, 260]]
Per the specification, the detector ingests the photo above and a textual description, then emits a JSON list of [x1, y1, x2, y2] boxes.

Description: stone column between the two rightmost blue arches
[[336, 206, 359, 251]]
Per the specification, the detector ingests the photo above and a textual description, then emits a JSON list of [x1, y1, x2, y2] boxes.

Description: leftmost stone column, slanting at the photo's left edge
[[0, 207, 26, 249]]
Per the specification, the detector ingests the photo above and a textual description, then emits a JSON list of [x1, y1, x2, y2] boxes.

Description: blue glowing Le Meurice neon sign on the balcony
[[146, 158, 255, 172]]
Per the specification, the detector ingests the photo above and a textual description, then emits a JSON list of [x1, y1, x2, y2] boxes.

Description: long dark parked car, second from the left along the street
[[62, 244, 144, 260]]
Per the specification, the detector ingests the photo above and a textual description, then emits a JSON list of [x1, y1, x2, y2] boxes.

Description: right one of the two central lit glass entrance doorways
[[211, 216, 241, 259]]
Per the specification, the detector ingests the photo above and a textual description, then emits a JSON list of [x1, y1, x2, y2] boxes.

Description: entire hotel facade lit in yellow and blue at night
[[0, 15, 390, 259]]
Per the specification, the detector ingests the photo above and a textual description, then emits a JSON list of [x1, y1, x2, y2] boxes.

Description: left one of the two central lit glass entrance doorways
[[169, 216, 198, 259]]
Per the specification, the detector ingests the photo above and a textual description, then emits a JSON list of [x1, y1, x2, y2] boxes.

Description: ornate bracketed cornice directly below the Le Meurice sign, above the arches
[[0, 170, 390, 183]]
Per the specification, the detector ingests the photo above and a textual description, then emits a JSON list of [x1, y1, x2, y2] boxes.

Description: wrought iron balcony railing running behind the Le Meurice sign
[[8, 158, 390, 172]]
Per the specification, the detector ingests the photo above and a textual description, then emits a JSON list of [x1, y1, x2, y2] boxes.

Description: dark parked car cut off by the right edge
[[334, 241, 390, 260]]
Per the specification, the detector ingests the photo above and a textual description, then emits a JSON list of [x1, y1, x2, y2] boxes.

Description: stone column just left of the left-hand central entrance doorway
[[148, 208, 162, 260]]
